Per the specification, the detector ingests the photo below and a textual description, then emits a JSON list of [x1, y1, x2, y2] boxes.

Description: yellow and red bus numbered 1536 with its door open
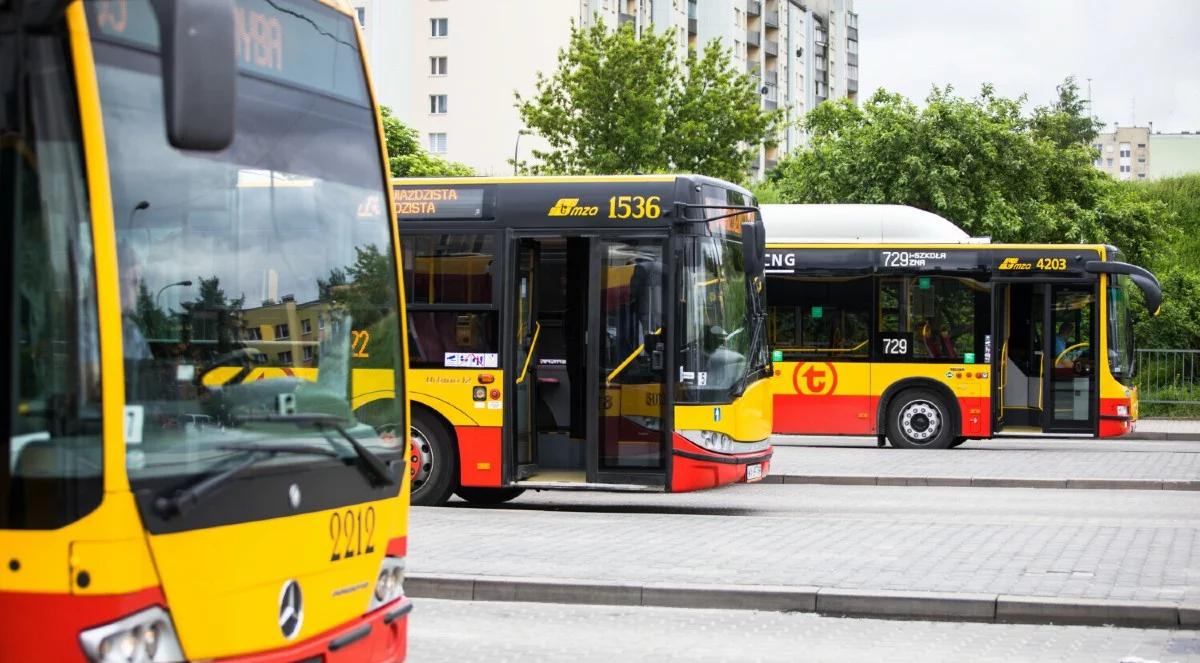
[[392, 175, 772, 504]]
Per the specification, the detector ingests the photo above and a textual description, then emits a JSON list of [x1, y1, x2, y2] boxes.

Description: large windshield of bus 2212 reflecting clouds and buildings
[[86, 0, 403, 506]]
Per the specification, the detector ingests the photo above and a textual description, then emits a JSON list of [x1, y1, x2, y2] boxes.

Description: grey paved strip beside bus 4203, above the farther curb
[[770, 435, 1200, 480]]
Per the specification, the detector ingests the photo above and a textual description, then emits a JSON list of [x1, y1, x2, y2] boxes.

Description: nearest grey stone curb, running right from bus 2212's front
[[404, 573, 1200, 628]]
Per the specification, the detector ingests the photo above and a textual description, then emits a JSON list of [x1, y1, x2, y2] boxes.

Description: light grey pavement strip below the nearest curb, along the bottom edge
[[408, 599, 1200, 663]]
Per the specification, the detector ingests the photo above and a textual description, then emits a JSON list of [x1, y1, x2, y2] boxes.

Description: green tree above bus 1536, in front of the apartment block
[[516, 17, 780, 181]]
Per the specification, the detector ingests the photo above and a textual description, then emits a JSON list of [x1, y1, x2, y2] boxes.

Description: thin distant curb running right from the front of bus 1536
[[761, 474, 1200, 490]]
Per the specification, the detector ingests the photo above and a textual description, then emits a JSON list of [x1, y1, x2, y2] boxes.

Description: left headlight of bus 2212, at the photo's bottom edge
[[79, 605, 184, 663]]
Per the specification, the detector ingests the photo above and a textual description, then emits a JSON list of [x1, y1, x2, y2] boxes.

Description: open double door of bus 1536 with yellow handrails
[[505, 235, 671, 486]]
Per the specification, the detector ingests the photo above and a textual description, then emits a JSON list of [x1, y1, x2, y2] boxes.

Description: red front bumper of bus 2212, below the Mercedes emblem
[[217, 597, 413, 663]]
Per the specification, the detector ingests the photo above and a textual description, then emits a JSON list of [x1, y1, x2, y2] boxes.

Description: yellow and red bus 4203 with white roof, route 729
[[763, 205, 1162, 448]]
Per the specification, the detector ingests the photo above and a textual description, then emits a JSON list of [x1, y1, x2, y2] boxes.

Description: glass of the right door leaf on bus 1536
[[592, 239, 667, 475]]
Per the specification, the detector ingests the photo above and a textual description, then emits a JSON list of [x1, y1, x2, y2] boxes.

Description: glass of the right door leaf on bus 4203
[[1045, 283, 1096, 432]]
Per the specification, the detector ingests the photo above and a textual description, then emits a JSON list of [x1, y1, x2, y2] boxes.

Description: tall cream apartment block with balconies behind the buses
[[354, 0, 858, 174]]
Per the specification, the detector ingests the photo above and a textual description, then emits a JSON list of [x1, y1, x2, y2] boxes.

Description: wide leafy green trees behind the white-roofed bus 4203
[[770, 79, 1170, 259]]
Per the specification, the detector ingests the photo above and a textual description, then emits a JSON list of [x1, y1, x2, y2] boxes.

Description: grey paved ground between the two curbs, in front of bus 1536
[[409, 484, 1200, 605]]
